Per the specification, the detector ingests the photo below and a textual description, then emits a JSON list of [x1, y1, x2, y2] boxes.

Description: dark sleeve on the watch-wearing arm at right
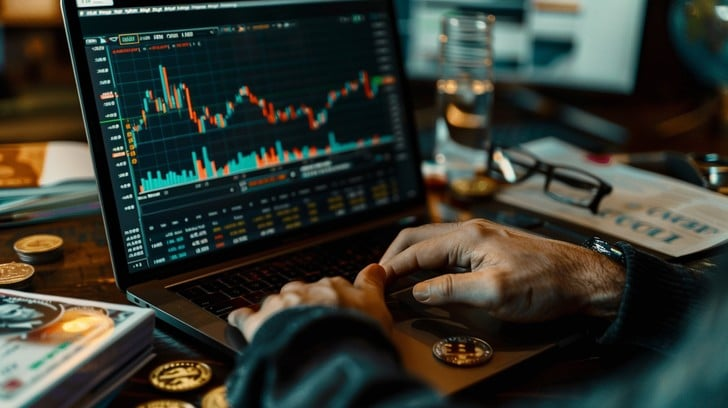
[[600, 242, 708, 352]]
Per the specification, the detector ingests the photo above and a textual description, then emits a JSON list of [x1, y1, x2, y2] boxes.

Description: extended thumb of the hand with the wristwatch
[[412, 272, 496, 306]]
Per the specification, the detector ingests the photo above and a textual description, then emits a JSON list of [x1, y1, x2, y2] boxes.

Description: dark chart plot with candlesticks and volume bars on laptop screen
[[108, 31, 396, 193]]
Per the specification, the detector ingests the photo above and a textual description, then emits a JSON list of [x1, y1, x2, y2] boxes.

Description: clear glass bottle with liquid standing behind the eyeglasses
[[433, 11, 495, 190]]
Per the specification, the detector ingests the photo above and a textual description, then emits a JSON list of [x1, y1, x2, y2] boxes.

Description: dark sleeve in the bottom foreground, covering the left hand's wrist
[[227, 307, 458, 407]]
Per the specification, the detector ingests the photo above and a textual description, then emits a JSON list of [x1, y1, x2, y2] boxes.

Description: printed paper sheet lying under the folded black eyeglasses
[[496, 138, 728, 257]]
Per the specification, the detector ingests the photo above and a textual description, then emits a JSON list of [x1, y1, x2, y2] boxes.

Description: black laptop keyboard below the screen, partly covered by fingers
[[174, 227, 399, 319]]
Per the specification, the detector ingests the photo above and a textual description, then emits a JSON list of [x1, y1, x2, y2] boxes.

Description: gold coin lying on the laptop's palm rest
[[432, 336, 493, 367]]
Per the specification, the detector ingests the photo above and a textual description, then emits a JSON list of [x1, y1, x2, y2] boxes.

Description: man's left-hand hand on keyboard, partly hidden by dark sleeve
[[228, 264, 392, 341]]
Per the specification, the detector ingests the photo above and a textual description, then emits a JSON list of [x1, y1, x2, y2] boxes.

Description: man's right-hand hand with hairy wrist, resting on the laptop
[[380, 219, 625, 322]]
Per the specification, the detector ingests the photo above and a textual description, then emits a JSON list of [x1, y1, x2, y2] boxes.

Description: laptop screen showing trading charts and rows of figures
[[64, 0, 423, 275]]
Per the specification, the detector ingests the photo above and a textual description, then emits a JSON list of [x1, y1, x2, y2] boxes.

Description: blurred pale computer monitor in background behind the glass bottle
[[396, 0, 647, 94]]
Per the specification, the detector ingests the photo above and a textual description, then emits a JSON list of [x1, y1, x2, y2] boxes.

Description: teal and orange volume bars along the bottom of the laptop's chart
[[139, 132, 394, 193]]
